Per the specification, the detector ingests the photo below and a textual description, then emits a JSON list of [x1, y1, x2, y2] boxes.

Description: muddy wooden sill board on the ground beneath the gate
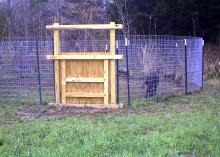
[[49, 103, 124, 109]]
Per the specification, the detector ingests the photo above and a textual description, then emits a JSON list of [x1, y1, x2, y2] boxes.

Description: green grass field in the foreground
[[0, 80, 220, 157]]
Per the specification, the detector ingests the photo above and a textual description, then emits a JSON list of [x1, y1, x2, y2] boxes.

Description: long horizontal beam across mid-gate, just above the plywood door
[[47, 55, 123, 60]]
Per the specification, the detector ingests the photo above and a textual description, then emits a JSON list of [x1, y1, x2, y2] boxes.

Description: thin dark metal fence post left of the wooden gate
[[35, 37, 42, 104]]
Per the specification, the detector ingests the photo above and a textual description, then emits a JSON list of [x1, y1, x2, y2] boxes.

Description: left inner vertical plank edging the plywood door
[[61, 60, 66, 104]]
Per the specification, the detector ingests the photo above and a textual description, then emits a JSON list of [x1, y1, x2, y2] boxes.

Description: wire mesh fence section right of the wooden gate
[[118, 36, 202, 104]]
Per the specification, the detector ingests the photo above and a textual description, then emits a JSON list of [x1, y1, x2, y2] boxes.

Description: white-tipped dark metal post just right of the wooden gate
[[125, 37, 131, 106]]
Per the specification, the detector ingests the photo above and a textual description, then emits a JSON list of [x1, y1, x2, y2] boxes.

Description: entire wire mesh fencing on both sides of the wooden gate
[[0, 35, 203, 104]]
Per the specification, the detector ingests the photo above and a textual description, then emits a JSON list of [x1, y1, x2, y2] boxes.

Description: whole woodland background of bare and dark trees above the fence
[[0, 0, 220, 43]]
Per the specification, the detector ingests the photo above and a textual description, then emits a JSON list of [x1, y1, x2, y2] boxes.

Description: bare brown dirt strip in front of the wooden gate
[[16, 105, 165, 119]]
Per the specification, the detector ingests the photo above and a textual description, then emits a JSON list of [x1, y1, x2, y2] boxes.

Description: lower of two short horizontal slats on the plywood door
[[66, 92, 104, 98]]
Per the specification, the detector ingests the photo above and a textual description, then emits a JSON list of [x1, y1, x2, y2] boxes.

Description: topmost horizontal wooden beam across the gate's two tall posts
[[46, 24, 123, 30]]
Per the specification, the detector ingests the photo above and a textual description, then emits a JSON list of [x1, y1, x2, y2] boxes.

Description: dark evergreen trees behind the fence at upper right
[[108, 0, 220, 41]]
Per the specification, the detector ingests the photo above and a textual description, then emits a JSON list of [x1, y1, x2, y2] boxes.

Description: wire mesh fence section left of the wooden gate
[[0, 38, 54, 103]]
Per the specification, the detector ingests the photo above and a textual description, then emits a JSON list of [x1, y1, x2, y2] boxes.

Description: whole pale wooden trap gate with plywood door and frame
[[46, 22, 123, 106]]
